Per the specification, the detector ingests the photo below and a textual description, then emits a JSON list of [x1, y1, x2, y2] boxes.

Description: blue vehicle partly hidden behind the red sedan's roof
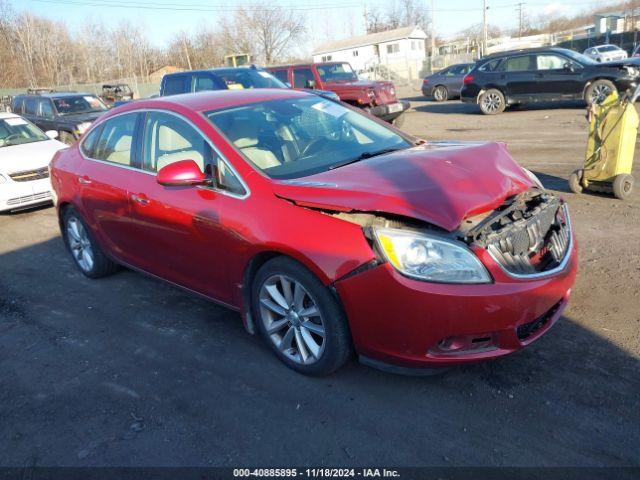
[[160, 65, 340, 101]]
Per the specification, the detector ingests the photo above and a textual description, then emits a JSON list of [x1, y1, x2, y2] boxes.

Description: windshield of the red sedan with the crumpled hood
[[206, 96, 413, 179]]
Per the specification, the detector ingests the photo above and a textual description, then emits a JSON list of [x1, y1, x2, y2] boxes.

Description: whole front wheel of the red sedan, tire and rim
[[251, 257, 352, 375]]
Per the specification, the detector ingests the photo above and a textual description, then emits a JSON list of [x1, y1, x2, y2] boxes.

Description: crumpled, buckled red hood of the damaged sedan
[[274, 143, 533, 231]]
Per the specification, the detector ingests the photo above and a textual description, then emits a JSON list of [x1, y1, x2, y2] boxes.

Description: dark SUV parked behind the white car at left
[[11, 92, 109, 145]]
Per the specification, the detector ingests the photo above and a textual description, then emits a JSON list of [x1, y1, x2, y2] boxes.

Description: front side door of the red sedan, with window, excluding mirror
[[124, 112, 243, 303]]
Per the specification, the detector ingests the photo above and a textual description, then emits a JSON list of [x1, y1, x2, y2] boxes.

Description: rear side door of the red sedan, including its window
[[77, 113, 144, 264]]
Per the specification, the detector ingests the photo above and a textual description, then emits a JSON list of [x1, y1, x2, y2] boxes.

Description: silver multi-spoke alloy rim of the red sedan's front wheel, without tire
[[259, 275, 325, 365]]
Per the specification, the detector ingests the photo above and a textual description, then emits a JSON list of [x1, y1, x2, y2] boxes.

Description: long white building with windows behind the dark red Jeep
[[313, 26, 427, 79]]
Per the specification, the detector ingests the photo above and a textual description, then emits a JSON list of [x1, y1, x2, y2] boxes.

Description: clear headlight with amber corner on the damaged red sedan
[[375, 228, 491, 283]]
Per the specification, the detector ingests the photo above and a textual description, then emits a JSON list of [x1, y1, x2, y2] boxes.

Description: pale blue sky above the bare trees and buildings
[[21, 0, 614, 53]]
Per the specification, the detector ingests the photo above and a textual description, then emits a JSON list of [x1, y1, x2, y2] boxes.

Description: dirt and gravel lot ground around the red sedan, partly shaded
[[0, 93, 640, 466]]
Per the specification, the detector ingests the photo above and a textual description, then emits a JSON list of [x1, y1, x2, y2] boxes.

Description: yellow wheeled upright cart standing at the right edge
[[569, 86, 640, 200]]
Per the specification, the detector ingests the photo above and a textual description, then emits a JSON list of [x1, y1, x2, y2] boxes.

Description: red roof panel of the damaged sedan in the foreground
[[108, 88, 319, 116]]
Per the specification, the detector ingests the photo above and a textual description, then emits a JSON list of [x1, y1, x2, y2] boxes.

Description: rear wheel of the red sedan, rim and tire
[[62, 207, 118, 278]]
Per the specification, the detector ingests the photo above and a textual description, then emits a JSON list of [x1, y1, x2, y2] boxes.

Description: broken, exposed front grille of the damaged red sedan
[[464, 192, 571, 276]]
